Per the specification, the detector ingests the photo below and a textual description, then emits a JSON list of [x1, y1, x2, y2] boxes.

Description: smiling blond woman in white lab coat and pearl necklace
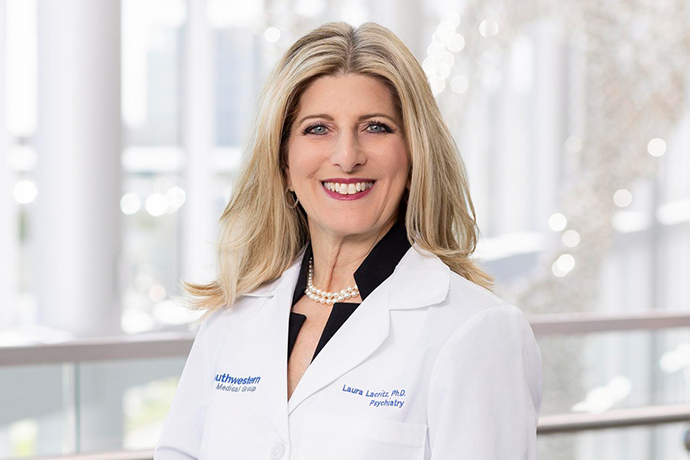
[[154, 22, 541, 460]]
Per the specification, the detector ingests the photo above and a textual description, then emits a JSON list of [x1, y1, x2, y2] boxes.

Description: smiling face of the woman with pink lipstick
[[286, 75, 409, 236]]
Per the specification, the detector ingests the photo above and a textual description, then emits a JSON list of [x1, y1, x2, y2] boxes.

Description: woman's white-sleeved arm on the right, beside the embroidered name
[[428, 305, 542, 460]]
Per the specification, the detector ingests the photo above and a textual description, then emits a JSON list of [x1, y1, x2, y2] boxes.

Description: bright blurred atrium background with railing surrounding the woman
[[0, 0, 690, 460]]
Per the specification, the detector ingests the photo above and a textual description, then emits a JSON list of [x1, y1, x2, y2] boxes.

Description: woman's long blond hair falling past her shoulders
[[182, 22, 493, 320]]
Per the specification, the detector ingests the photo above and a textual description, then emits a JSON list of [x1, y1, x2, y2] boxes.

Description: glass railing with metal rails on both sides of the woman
[[0, 312, 690, 460]]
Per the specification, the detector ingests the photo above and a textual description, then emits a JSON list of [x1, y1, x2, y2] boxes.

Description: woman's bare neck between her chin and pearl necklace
[[309, 220, 395, 291]]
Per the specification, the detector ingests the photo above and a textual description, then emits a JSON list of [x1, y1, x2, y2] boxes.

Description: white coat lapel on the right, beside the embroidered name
[[288, 244, 450, 414]]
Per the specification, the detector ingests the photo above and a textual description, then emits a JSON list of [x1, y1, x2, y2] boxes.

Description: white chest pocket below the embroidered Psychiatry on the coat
[[300, 413, 427, 460]]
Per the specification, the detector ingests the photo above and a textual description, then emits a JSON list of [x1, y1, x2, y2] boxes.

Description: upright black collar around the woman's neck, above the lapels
[[292, 222, 410, 305]]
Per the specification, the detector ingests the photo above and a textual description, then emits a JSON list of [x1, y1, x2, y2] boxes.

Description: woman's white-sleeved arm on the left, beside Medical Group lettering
[[153, 315, 215, 460]]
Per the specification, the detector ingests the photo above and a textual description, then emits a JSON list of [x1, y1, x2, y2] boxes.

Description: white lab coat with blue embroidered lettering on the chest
[[154, 244, 542, 460]]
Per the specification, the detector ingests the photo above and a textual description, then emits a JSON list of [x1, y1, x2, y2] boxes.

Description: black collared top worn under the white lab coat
[[288, 222, 410, 361]]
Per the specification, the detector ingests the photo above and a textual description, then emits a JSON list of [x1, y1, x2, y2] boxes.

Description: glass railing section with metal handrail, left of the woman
[[0, 333, 193, 459]]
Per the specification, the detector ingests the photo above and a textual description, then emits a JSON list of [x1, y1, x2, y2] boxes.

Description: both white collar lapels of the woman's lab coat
[[245, 243, 450, 421]]
